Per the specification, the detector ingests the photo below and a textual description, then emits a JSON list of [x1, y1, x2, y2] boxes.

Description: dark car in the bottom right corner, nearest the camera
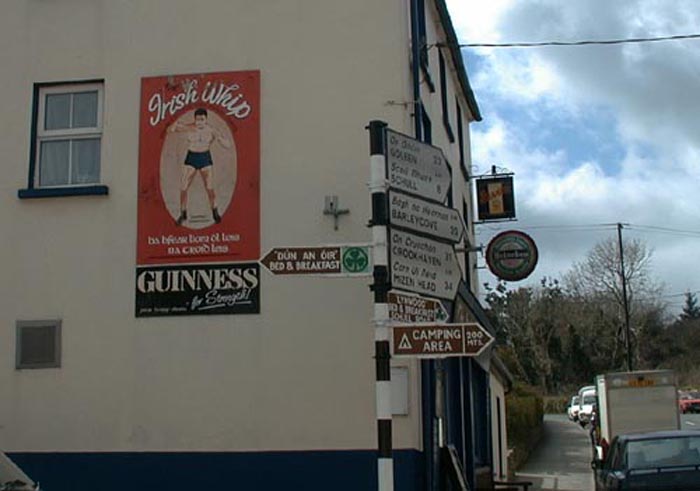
[[593, 430, 700, 491]]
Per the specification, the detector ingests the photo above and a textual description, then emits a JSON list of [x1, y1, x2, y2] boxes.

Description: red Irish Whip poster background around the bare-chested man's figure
[[137, 70, 260, 265]]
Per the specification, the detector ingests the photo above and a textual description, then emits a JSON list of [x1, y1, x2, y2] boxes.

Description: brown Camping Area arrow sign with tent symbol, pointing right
[[392, 323, 494, 358]]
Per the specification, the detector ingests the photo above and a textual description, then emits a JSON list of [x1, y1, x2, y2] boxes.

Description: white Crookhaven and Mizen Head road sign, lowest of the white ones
[[389, 229, 462, 300]]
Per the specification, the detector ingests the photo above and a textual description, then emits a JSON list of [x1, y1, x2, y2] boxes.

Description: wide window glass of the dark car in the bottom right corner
[[627, 435, 700, 469]]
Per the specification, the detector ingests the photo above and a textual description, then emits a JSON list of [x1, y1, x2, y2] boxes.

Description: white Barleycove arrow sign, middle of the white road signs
[[389, 190, 464, 243]]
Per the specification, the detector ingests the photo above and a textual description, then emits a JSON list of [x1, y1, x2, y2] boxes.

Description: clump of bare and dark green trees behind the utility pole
[[486, 236, 668, 393]]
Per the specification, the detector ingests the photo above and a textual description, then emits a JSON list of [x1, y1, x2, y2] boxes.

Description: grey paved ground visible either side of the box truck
[[516, 414, 700, 491]]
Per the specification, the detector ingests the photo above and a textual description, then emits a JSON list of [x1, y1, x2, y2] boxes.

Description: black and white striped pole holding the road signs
[[369, 121, 394, 491]]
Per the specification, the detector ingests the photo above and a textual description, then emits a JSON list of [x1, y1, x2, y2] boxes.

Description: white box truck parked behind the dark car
[[594, 370, 680, 459]]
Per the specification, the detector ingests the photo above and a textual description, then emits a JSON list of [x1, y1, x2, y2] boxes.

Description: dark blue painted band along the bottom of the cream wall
[[8, 450, 425, 491]]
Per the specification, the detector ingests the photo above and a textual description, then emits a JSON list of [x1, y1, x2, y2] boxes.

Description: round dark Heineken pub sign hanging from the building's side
[[486, 230, 537, 281]]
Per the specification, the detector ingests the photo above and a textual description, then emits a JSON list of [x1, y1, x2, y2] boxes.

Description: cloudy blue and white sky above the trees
[[447, 0, 700, 311]]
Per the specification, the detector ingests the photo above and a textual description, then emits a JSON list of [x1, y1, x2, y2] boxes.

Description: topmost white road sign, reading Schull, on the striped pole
[[386, 130, 452, 203]]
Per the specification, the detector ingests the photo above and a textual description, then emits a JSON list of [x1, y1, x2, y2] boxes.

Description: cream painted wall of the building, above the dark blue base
[[0, 0, 478, 462]]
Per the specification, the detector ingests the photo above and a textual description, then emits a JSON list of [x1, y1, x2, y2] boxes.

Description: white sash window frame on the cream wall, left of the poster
[[33, 82, 104, 189]]
